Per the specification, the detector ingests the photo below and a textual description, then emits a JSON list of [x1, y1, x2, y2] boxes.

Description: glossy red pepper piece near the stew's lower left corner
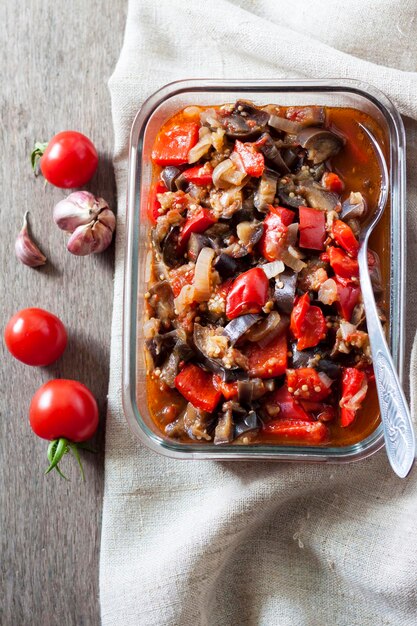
[[175, 363, 222, 413]]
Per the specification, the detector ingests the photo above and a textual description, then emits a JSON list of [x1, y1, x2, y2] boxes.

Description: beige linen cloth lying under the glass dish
[[100, 0, 417, 626]]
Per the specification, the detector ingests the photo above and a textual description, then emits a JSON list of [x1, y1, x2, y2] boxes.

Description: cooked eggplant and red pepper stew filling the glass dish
[[144, 100, 385, 445]]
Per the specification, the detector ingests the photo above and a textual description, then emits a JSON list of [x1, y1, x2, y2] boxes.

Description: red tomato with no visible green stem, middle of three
[[4, 308, 67, 366]]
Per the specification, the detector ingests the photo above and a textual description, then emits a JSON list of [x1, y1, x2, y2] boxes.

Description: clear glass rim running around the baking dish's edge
[[122, 79, 406, 462]]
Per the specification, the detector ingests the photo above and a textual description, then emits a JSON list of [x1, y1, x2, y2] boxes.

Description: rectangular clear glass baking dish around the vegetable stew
[[122, 80, 406, 462]]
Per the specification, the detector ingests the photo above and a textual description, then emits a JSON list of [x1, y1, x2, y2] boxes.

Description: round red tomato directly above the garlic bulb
[[40, 130, 98, 189]]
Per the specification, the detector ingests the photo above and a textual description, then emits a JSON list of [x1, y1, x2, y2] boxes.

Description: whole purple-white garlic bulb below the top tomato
[[53, 191, 116, 256]]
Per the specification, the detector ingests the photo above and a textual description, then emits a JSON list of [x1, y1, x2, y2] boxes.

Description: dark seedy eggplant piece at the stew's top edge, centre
[[221, 100, 269, 140]]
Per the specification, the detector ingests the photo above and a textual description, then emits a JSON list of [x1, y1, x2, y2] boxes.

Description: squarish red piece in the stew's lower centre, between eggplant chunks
[[245, 334, 288, 378]]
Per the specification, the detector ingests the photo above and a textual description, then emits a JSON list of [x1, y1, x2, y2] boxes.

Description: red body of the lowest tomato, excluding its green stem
[[29, 379, 98, 442]]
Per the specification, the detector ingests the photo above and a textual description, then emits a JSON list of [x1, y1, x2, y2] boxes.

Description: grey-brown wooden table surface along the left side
[[0, 0, 127, 626]]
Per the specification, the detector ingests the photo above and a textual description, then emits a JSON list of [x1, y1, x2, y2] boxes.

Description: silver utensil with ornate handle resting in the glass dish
[[358, 124, 415, 478]]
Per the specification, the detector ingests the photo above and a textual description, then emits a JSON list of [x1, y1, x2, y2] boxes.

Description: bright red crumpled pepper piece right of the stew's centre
[[290, 293, 327, 350]]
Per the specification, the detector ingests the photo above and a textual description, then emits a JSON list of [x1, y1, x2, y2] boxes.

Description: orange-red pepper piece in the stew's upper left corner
[[152, 122, 199, 167]]
